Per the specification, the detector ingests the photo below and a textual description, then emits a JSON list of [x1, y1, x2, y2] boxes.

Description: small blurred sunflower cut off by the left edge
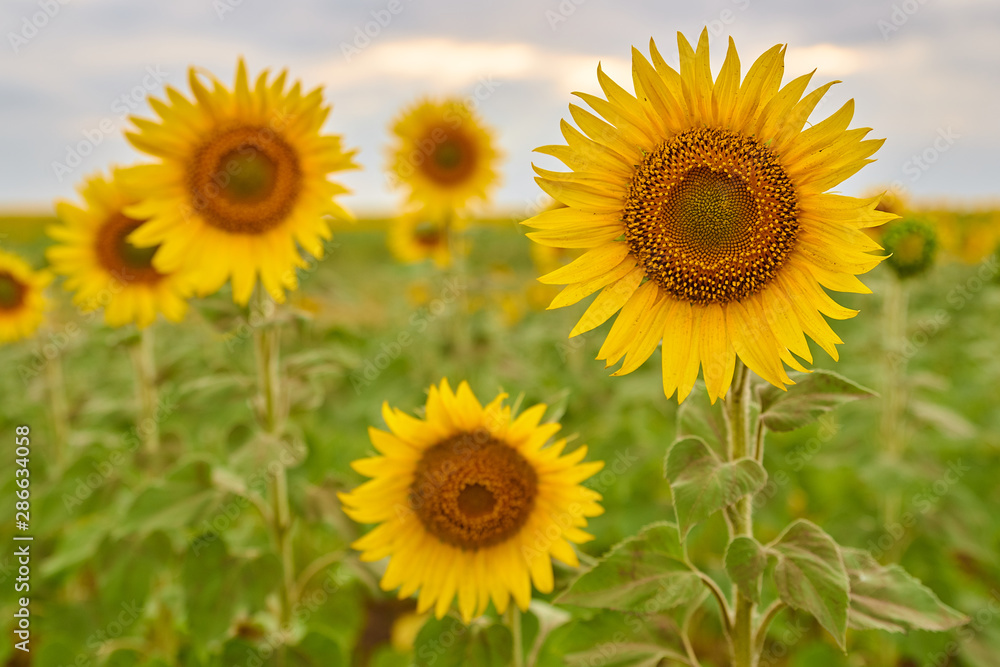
[[0, 250, 52, 343]]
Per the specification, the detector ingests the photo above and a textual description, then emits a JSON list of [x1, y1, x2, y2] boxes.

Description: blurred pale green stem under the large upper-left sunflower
[[251, 285, 296, 664]]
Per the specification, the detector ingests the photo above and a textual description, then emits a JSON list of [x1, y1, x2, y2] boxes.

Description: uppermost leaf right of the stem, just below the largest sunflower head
[[758, 369, 877, 431]]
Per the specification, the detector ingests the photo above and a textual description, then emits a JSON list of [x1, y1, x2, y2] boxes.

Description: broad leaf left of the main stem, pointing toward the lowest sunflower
[[556, 522, 703, 613]]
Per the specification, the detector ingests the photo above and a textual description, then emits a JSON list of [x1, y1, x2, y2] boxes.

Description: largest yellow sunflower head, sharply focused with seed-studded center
[[524, 30, 895, 402]]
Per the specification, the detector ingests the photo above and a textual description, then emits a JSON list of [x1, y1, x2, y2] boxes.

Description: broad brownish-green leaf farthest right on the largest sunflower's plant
[[843, 549, 969, 632]]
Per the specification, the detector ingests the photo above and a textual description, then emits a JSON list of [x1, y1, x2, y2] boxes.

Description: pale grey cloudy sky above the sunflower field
[[0, 0, 1000, 213]]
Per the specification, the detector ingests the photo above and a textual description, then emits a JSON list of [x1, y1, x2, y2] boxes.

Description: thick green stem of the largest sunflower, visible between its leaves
[[725, 360, 757, 667]]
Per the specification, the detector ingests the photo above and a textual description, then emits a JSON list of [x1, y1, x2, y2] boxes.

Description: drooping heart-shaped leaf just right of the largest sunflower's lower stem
[[769, 519, 850, 648]]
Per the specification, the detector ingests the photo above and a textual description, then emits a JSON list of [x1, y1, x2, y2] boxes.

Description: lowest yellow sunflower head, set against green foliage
[[340, 380, 604, 622]]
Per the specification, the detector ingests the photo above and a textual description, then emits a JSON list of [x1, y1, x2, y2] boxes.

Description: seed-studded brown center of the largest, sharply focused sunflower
[[623, 129, 799, 304]]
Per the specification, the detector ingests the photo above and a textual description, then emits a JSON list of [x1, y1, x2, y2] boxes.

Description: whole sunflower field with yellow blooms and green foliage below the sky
[[0, 3, 1000, 667]]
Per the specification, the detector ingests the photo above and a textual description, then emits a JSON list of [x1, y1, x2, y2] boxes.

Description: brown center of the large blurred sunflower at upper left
[[188, 125, 302, 234]]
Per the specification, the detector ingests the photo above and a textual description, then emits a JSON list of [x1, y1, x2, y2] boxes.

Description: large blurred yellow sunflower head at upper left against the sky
[[126, 59, 356, 304]]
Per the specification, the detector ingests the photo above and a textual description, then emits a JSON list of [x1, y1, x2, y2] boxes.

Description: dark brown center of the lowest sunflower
[[410, 430, 538, 550]]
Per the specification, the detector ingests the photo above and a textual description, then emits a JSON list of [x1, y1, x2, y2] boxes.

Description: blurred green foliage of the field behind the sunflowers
[[0, 220, 1000, 667]]
